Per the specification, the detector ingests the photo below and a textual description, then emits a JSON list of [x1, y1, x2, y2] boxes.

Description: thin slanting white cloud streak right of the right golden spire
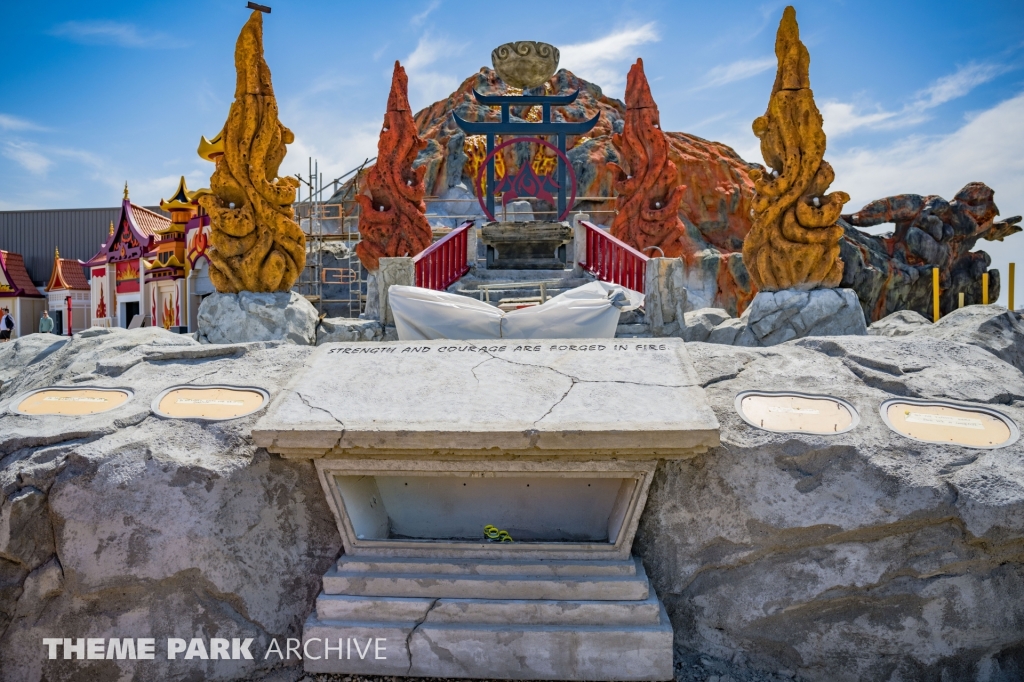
[[821, 63, 1009, 137]]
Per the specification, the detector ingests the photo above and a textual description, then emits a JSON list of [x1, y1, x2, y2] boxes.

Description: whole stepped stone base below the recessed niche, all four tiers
[[303, 556, 673, 680]]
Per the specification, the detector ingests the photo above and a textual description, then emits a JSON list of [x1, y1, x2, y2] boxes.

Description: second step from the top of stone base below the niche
[[324, 563, 650, 601]]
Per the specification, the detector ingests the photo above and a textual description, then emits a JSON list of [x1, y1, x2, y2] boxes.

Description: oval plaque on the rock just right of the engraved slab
[[736, 391, 860, 435]]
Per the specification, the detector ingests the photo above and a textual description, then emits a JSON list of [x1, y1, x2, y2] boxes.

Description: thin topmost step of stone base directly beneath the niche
[[337, 555, 637, 577]]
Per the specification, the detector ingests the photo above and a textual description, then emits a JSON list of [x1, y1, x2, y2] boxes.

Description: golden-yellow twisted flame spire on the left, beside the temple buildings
[[200, 11, 306, 293]]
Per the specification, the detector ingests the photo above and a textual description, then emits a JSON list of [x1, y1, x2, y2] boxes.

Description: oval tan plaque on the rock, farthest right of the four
[[880, 398, 1020, 450]]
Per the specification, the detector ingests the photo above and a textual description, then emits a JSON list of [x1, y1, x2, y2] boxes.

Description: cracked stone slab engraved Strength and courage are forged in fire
[[253, 339, 719, 457]]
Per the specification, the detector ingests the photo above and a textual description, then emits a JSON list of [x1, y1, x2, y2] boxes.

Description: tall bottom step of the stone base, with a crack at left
[[302, 607, 673, 680]]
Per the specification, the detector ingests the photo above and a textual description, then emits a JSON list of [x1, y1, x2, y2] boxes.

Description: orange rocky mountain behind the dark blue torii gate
[[332, 68, 754, 313]]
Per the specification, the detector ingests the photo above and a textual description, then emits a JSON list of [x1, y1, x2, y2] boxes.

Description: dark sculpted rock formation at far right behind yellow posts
[[840, 182, 1021, 321]]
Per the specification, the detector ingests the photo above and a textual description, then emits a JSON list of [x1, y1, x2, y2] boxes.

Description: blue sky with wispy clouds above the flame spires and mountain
[[0, 0, 1024, 299]]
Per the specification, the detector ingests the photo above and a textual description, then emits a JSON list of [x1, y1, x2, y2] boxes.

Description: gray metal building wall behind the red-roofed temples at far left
[[0, 206, 166, 287]]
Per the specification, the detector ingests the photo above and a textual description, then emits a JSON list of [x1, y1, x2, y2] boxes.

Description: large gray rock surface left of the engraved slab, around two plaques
[[0, 328, 341, 682]]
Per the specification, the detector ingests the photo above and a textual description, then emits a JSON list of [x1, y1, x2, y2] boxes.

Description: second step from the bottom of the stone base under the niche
[[316, 593, 660, 626]]
